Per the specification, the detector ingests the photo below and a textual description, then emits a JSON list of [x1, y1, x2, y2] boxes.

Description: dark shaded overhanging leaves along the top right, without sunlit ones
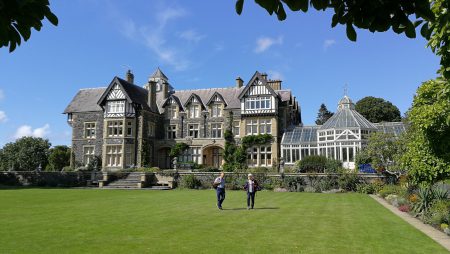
[[236, 0, 434, 41]]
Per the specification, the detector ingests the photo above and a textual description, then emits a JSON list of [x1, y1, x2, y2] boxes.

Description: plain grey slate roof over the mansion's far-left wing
[[64, 87, 106, 114]]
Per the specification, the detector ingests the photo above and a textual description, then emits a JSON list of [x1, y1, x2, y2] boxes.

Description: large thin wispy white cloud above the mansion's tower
[[119, 7, 193, 70]]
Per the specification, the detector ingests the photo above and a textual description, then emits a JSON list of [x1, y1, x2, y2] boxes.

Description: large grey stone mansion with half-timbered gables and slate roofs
[[64, 68, 301, 171]]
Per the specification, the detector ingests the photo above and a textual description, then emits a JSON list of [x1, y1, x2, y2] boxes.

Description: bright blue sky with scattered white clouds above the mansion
[[0, 0, 439, 146]]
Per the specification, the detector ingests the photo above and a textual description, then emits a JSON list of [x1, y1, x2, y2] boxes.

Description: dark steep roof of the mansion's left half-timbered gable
[[97, 77, 151, 111]]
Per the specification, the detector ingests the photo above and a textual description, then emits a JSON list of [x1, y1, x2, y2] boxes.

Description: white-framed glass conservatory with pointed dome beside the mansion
[[281, 96, 405, 169]]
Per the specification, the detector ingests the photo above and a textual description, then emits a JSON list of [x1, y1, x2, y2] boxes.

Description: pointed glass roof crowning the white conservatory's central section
[[320, 95, 377, 130]]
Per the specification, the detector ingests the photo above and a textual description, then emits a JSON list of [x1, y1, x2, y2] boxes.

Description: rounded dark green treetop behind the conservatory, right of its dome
[[355, 96, 401, 123]]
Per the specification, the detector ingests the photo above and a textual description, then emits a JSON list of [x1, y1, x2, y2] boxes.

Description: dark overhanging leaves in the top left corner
[[0, 0, 58, 52]]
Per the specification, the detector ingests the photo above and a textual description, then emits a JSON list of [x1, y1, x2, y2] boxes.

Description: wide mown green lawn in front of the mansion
[[0, 189, 447, 254]]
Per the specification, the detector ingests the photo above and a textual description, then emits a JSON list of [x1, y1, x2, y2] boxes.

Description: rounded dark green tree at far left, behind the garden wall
[[0, 137, 51, 171]]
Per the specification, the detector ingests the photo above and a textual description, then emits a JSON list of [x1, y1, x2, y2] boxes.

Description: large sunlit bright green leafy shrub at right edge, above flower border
[[402, 78, 450, 183]]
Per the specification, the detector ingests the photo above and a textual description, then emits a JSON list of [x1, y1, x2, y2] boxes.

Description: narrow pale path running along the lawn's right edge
[[369, 195, 450, 251]]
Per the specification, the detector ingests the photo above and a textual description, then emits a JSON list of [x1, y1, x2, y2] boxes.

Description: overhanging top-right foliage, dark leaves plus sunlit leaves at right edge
[[236, 0, 450, 79]]
